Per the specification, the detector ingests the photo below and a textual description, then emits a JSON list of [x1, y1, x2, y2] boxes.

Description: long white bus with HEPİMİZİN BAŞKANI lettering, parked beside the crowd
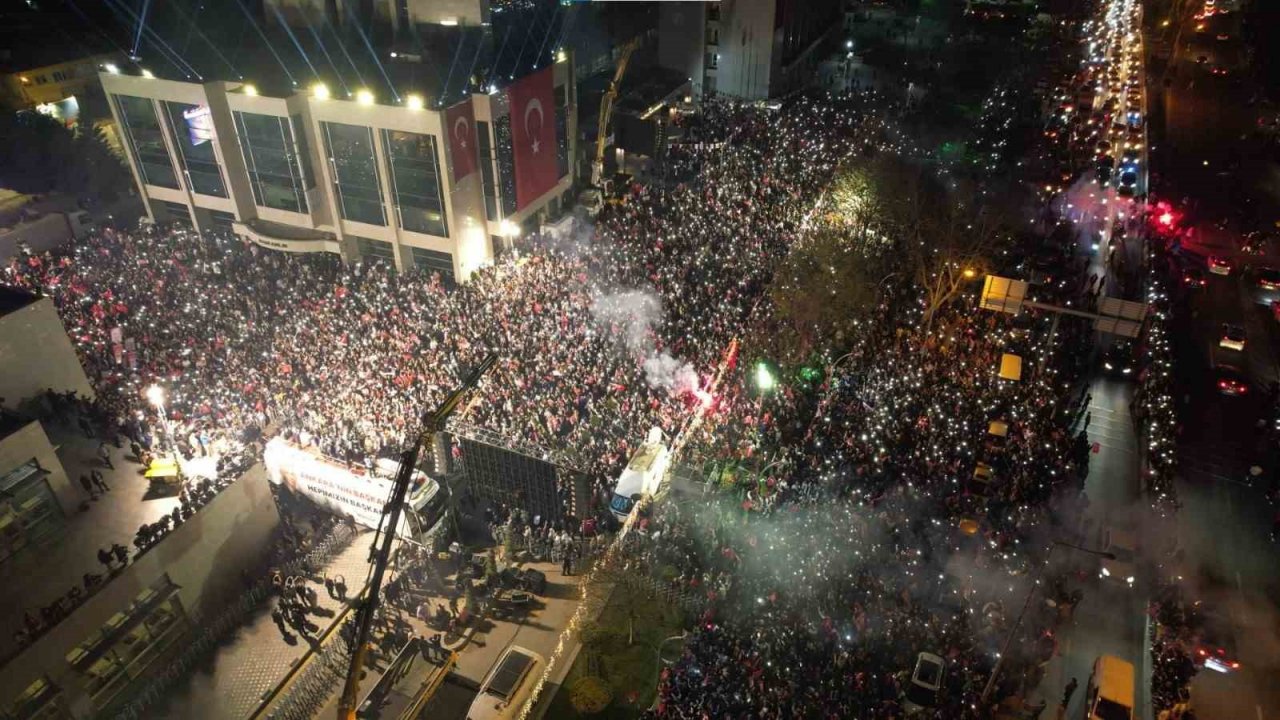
[[262, 438, 443, 537]]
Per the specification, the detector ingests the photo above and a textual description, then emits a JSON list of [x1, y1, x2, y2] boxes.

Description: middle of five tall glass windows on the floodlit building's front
[[234, 113, 314, 213]]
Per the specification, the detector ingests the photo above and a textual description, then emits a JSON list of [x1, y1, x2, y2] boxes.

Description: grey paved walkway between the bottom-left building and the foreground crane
[[154, 530, 372, 720]]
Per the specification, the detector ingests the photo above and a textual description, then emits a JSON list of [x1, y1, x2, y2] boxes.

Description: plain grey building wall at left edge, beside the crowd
[[0, 297, 93, 407]]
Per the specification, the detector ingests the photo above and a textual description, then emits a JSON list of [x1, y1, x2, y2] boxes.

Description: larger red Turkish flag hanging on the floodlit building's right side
[[507, 67, 559, 210]]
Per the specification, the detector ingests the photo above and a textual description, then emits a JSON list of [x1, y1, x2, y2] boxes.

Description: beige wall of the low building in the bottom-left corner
[[0, 464, 280, 717]]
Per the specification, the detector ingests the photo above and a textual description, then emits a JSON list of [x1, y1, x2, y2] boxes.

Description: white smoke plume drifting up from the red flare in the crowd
[[591, 290, 701, 392]]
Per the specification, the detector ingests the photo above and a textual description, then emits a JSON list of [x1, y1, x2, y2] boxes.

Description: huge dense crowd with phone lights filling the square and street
[[4, 77, 1116, 719]]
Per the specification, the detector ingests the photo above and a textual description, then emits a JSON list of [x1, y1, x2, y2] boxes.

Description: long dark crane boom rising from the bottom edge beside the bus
[[338, 355, 498, 720]]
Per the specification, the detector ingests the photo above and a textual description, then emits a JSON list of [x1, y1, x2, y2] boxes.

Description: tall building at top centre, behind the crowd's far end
[[658, 0, 842, 100]]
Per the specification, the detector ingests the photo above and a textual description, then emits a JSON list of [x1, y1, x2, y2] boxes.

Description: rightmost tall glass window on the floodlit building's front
[[381, 129, 449, 237]]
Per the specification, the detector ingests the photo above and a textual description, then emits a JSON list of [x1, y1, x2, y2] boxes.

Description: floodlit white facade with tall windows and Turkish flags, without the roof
[[100, 53, 577, 281]]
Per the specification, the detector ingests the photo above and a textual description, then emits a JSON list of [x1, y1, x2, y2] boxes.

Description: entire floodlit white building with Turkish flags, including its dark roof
[[100, 0, 577, 281]]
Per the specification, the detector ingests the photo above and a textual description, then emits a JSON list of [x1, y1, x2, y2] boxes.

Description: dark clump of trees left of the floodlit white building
[[0, 111, 129, 199]]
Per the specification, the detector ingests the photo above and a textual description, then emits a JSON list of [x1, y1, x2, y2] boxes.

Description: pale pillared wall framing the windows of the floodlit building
[[100, 56, 577, 279]]
